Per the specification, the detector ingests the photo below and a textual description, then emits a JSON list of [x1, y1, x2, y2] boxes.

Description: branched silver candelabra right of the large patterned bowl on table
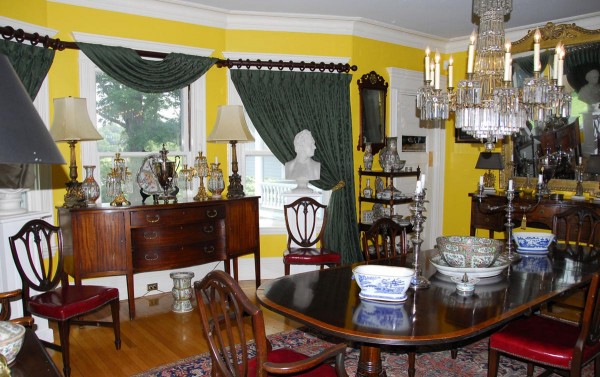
[[475, 180, 543, 262]]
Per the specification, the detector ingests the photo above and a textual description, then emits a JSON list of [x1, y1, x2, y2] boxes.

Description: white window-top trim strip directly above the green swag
[[72, 31, 214, 56]]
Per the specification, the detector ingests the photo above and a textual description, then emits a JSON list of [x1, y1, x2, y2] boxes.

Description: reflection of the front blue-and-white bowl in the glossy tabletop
[[352, 300, 410, 331]]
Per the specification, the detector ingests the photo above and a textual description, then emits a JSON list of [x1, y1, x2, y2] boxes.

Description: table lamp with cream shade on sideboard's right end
[[207, 105, 254, 198]]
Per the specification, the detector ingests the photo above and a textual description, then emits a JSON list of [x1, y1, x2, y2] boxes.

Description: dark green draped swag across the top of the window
[[77, 42, 218, 93]]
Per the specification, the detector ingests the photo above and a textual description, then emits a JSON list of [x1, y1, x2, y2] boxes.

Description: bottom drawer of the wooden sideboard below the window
[[132, 238, 226, 272]]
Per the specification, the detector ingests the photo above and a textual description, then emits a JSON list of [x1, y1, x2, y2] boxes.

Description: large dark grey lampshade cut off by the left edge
[[0, 54, 65, 164]]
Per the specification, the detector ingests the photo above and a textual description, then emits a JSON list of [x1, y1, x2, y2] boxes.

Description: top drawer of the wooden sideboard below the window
[[131, 205, 225, 227]]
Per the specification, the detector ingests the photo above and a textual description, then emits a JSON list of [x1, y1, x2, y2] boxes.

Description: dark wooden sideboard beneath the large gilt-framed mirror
[[469, 194, 600, 238]]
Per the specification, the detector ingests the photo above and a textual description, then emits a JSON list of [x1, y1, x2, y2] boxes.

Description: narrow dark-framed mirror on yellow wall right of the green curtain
[[357, 71, 388, 154]]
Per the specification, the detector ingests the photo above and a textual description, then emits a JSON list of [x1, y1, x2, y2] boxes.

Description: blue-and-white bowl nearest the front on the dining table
[[352, 264, 414, 301]]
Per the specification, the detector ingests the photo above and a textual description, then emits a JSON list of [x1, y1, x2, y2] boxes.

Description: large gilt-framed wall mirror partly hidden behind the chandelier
[[504, 23, 600, 191]]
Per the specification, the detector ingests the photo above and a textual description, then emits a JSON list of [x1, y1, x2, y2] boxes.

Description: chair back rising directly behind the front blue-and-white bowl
[[362, 217, 407, 262]]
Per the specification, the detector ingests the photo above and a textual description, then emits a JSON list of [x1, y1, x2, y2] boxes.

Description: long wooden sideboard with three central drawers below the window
[[58, 197, 260, 319]]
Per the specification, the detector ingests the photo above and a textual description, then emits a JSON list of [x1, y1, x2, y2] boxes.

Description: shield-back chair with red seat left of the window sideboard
[[8, 220, 121, 377]]
